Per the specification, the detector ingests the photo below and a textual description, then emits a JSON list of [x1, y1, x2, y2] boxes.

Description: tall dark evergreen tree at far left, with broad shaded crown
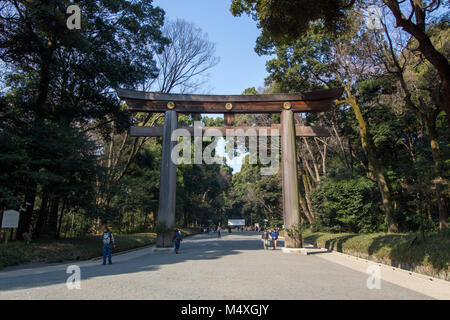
[[0, 0, 167, 237]]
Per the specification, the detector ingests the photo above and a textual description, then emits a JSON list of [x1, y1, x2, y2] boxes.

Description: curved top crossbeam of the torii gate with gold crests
[[117, 88, 343, 113]]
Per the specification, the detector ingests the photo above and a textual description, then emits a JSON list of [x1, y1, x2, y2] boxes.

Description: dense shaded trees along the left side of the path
[[0, 0, 226, 238]]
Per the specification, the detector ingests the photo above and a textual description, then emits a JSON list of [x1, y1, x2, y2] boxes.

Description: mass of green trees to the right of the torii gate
[[231, 0, 450, 232]]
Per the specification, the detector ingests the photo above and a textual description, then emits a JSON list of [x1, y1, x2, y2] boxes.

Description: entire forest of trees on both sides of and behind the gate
[[0, 0, 450, 239]]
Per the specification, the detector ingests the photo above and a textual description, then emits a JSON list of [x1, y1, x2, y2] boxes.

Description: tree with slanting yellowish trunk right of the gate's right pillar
[[258, 13, 397, 231]]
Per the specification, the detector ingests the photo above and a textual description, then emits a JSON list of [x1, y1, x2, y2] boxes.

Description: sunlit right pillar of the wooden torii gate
[[280, 110, 302, 248]]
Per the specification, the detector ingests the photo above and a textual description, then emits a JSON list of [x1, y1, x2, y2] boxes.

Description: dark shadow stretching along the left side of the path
[[0, 233, 262, 291]]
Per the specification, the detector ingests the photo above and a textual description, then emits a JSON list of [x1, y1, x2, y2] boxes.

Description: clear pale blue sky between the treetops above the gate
[[154, 0, 269, 173]]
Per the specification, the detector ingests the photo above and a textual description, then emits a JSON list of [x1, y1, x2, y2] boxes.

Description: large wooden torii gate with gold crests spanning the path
[[117, 88, 343, 248]]
